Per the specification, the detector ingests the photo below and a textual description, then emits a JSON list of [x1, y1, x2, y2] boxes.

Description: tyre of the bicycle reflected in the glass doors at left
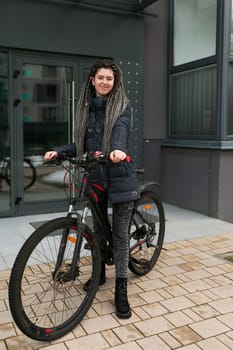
[[4, 158, 37, 190]]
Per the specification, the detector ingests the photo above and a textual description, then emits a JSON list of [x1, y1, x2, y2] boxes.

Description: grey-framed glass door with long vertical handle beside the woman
[[11, 55, 78, 215]]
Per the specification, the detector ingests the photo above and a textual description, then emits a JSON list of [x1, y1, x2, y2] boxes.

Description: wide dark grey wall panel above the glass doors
[[0, 0, 144, 61]]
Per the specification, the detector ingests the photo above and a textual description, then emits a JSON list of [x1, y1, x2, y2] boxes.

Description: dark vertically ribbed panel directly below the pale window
[[170, 65, 217, 139]]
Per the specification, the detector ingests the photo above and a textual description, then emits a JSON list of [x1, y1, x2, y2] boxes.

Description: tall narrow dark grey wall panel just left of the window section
[[143, 0, 169, 140]]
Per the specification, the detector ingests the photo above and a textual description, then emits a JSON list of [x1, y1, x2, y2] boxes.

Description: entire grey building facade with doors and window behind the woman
[[0, 0, 233, 222]]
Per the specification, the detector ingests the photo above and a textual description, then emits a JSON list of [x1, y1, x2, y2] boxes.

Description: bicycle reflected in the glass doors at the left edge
[[0, 157, 36, 190]]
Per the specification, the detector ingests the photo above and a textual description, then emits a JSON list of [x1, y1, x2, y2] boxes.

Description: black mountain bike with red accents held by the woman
[[9, 154, 165, 341]]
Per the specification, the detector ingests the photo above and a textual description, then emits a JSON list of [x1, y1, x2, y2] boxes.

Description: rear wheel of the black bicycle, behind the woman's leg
[[129, 191, 165, 276]]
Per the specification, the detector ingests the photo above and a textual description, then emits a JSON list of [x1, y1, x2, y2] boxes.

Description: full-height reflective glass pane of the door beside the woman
[[22, 64, 72, 202]]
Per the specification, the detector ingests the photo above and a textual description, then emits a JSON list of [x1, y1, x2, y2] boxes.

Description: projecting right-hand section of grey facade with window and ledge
[[162, 0, 233, 222]]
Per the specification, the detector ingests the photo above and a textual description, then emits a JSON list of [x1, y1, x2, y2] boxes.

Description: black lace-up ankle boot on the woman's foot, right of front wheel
[[115, 277, 131, 318]]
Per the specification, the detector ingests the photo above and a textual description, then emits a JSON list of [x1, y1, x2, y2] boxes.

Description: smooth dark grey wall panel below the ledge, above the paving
[[162, 148, 214, 215]]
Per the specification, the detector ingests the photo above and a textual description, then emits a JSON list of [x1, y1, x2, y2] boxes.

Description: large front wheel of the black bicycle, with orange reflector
[[9, 217, 101, 341]]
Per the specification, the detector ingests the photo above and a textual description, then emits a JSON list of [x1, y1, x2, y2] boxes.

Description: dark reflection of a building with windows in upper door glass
[[22, 64, 71, 156]]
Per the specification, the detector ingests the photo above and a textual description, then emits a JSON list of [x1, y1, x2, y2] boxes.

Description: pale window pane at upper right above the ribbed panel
[[173, 0, 218, 66]]
